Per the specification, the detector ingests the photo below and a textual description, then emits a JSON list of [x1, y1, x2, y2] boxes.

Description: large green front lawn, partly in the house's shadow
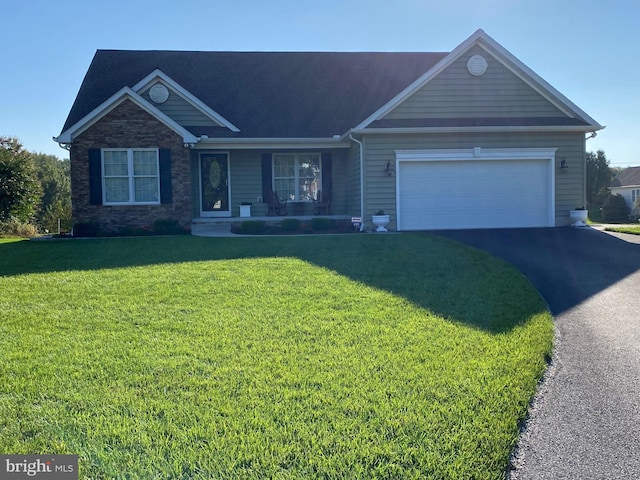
[[0, 234, 553, 479]]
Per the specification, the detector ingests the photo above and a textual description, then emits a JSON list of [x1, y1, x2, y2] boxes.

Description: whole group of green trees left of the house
[[0, 136, 72, 236]]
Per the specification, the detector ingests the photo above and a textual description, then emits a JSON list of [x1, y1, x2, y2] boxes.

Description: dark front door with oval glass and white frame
[[200, 153, 231, 217]]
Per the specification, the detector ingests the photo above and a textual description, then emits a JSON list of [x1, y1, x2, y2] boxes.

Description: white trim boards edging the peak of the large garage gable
[[353, 29, 604, 132]]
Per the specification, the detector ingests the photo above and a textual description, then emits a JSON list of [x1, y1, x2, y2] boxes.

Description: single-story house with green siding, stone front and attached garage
[[55, 30, 603, 230]]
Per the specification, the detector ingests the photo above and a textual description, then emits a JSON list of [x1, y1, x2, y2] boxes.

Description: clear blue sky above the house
[[0, 0, 640, 167]]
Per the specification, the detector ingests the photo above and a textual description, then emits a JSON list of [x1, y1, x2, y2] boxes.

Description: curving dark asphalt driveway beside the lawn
[[438, 227, 640, 480]]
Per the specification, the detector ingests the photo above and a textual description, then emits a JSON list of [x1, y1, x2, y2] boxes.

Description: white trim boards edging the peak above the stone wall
[[54, 87, 198, 144]]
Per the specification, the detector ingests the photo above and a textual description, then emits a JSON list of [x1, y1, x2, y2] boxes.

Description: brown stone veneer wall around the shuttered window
[[70, 100, 192, 232]]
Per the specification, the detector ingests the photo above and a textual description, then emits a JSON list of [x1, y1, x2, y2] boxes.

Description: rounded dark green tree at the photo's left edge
[[0, 136, 42, 223]]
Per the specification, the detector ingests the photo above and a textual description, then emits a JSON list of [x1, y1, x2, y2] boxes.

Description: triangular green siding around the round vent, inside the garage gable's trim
[[384, 47, 566, 119]]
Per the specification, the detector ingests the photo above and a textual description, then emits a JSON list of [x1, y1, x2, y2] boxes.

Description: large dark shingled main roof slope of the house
[[62, 50, 447, 138]]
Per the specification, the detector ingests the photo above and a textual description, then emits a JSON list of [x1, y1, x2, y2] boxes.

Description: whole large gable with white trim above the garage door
[[352, 29, 604, 133]]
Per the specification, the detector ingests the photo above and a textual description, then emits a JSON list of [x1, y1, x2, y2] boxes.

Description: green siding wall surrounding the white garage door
[[364, 132, 585, 228]]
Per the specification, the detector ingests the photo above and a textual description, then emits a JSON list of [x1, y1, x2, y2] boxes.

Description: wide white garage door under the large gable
[[397, 159, 553, 230]]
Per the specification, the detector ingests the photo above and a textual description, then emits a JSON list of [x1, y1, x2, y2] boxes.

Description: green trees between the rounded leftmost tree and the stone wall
[[33, 153, 71, 232]]
